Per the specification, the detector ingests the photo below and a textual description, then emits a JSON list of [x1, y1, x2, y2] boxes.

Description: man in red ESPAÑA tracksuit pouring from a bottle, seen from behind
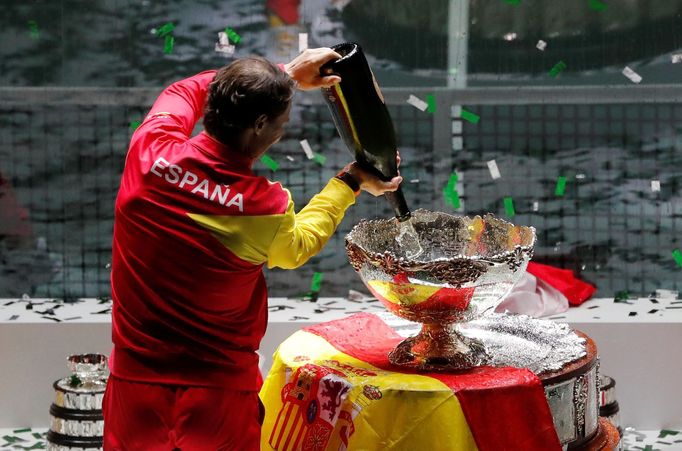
[[103, 49, 402, 451]]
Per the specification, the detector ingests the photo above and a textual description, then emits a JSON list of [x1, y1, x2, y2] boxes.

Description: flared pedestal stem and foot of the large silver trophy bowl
[[388, 323, 488, 371]]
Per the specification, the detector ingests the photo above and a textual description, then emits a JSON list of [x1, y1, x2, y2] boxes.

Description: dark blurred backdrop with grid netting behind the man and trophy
[[0, 0, 682, 300]]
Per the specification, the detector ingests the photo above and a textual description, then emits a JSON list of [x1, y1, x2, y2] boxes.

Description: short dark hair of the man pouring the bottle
[[204, 57, 295, 144]]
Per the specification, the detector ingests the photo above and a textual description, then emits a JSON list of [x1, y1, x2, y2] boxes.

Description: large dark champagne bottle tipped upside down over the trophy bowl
[[320, 42, 410, 222]]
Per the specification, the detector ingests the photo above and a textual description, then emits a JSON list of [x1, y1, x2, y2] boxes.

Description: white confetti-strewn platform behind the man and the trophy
[[0, 293, 682, 436]]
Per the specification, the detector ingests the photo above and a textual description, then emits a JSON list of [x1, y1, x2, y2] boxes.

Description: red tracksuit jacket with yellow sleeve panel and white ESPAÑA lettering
[[110, 71, 355, 390]]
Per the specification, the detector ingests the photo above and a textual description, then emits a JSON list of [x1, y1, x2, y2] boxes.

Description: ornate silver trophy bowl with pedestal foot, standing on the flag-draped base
[[346, 209, 535, 371]]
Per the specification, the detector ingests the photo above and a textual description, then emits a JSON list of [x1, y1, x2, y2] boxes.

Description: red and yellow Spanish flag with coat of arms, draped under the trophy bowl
[[260, 313, 561, 451]]
